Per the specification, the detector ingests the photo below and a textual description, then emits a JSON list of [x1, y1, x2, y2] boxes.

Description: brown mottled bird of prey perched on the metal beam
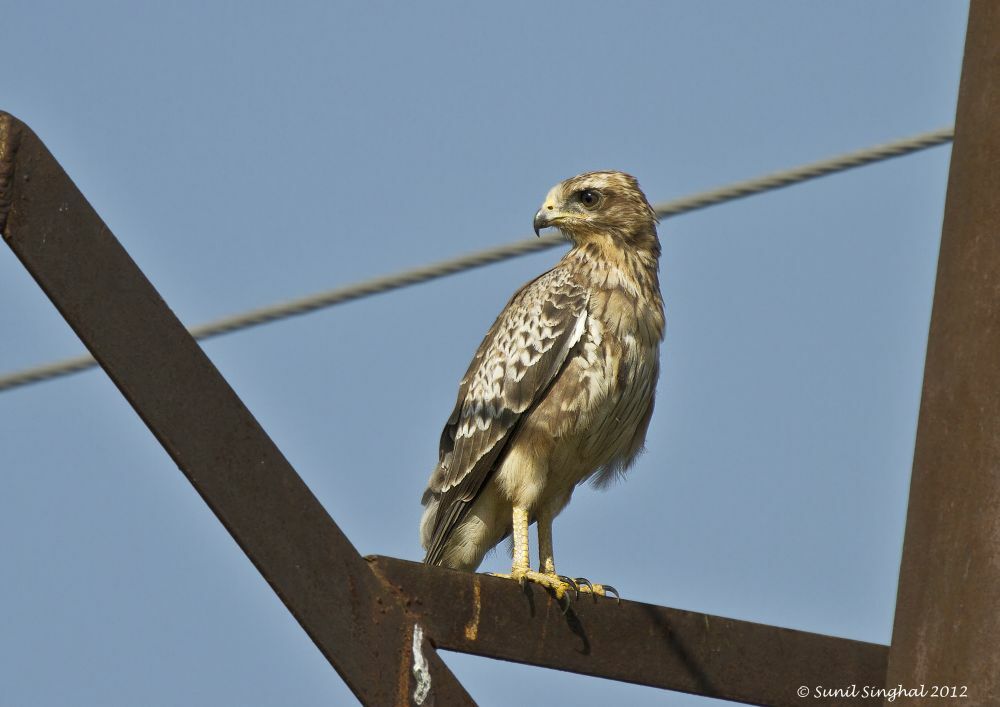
[[420, 171, 664, 599]]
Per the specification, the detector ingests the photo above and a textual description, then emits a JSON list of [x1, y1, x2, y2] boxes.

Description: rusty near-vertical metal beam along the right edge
[[886, 0, 1000, 706]]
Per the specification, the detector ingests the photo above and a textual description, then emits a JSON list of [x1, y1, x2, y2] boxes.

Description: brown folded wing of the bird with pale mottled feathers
[[423, 268, 587, 564]]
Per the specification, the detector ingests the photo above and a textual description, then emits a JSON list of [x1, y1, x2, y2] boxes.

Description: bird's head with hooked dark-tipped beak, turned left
[[534, 171, 660, 255]]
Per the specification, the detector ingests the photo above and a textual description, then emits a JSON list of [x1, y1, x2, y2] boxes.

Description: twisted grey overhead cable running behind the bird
[[0, 128, 954, 391]]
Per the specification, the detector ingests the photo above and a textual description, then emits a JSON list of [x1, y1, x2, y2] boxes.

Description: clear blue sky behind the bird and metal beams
[[0, 0, 967, 706]]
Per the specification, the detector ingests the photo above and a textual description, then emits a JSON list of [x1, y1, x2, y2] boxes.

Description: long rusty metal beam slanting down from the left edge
[[0, 113, 473, 705]]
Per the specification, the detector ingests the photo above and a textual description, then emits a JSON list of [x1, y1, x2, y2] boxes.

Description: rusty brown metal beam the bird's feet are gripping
[[368, 557, 888, 705]]
